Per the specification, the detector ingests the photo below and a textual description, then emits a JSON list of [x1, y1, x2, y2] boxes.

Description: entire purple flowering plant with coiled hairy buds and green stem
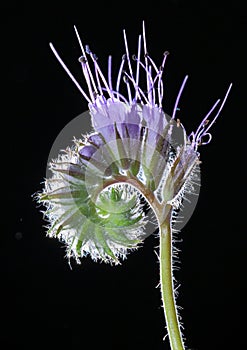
[[37, 23, 231, 350]]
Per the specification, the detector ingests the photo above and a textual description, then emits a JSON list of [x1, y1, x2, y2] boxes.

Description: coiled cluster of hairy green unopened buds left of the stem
[[38, 141, 146, 264]]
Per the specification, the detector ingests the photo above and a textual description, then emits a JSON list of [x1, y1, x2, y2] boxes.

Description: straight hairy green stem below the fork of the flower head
[[160, 215, 184, 350]]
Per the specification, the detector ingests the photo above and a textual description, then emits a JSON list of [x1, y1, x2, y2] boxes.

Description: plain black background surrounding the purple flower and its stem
[[3, 1, 247, 350]]
